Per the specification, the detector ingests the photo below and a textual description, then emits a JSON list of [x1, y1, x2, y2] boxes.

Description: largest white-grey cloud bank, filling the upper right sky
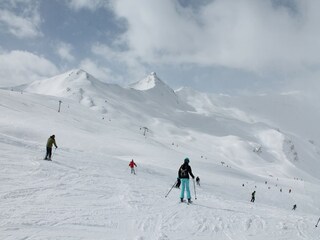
[[108, 0, 320, 77]]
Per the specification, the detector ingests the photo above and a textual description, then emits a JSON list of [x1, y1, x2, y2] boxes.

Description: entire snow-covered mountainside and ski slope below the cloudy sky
[[0, 70, 320, 240]]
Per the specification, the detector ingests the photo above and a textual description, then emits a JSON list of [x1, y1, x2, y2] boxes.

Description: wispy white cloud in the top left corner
[[0, 0, 42, 38]]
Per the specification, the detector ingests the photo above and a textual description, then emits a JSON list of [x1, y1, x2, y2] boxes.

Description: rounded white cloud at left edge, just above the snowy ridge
[[0, 50, 58, 87]]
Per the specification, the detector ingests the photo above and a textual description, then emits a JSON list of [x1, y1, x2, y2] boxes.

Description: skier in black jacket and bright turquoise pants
[[178, 158, 194, 203]]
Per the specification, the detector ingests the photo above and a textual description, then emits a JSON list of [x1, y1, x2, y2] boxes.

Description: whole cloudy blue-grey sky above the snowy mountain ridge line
[[0, 0, 320, 93]]
